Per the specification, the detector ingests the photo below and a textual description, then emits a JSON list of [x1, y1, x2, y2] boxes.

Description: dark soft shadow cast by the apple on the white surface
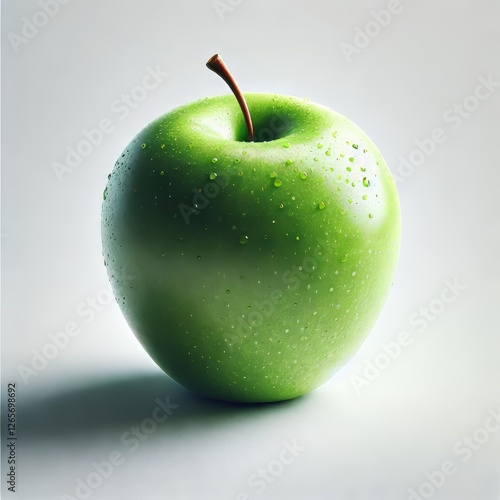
[[12, 373, 307, 440]]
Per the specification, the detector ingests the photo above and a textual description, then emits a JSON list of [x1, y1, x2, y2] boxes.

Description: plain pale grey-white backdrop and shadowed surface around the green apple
[[2, 0, 500, 500]]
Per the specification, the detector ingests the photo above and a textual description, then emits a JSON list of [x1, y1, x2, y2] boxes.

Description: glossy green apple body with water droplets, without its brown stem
[[102, 93, 401, 402]]
